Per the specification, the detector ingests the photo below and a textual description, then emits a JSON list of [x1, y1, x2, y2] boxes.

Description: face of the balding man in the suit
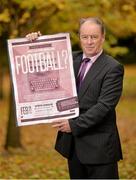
[[80, 21, 105, 57]]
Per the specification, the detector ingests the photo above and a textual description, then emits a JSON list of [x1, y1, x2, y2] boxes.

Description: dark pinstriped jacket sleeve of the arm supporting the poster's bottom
[[69, 64, 124, 136]]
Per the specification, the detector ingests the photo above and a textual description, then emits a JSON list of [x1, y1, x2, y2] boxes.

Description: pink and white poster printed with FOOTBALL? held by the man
[[8, 33, 79, 126]]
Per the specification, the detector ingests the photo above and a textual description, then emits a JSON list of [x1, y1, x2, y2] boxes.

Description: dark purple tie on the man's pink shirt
[[76, 58, 90, 91]]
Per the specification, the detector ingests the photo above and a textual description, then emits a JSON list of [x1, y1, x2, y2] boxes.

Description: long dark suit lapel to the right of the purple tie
[[78, 53, 106, 99]]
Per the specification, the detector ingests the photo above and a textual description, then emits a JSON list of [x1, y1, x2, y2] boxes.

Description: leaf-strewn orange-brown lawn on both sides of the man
[[0, 66, 136, 179]]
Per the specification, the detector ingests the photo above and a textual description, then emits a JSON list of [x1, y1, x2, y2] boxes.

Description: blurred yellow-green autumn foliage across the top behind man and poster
[[0, 0, 136, 64]]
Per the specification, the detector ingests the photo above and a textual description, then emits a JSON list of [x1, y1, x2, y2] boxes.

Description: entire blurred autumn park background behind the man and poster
[[0, 0, 136, 179]]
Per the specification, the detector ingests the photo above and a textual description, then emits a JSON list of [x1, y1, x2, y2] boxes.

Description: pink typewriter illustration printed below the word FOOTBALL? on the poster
[[28, 60, 60, 92]]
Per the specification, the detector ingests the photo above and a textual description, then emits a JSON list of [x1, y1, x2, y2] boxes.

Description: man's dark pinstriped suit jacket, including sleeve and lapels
[[55, 52, 124, 164]]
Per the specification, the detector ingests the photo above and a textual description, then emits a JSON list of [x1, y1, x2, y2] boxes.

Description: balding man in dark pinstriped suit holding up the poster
[[27, 17, 124, 179]]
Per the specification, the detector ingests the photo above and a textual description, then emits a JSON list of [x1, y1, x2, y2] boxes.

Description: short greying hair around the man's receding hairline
[[79, 17, 106, 34]]
